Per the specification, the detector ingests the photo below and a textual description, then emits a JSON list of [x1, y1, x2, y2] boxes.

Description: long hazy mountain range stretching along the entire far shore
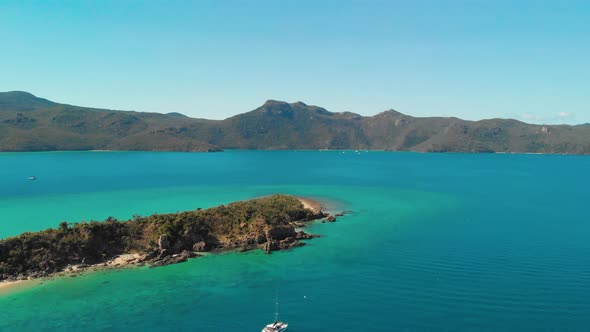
[[0, 91, 590, 154]]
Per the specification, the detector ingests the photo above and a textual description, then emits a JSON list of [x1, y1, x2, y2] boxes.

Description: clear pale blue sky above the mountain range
[[0, 0, 590, 123]]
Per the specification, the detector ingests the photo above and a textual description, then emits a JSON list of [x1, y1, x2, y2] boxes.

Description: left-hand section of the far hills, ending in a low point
[[0, 92, 219, 151]]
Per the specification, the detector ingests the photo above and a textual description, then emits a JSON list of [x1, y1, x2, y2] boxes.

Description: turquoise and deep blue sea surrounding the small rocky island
[[0, 151, 590, 332]]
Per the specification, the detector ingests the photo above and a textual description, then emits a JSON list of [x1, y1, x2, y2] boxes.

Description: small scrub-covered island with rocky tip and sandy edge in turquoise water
[[0, 195, 333, 281]]
